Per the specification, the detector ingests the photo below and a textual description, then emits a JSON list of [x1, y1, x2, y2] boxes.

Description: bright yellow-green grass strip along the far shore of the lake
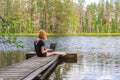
[[1, 33, 120, 36]]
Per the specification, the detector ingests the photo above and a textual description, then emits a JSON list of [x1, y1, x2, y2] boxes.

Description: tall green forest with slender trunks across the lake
[[0, 0, 120, 34]]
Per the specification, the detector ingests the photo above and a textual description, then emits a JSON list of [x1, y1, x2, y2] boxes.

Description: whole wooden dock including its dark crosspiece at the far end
[[0, 52, 77, 80]]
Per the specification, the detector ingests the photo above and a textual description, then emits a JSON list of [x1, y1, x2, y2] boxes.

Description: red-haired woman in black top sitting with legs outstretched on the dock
[[34, 30, 67, 57]]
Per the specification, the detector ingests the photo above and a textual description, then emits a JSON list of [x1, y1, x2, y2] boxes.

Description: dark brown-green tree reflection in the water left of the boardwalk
[[0, 51, 25, 68]]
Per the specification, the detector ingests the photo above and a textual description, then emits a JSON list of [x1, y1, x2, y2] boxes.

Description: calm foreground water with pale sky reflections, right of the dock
[[48, 53, 120, 80]]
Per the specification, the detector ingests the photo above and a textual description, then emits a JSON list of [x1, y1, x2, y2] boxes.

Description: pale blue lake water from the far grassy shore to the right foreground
[[0, 36, 120, 80]]
